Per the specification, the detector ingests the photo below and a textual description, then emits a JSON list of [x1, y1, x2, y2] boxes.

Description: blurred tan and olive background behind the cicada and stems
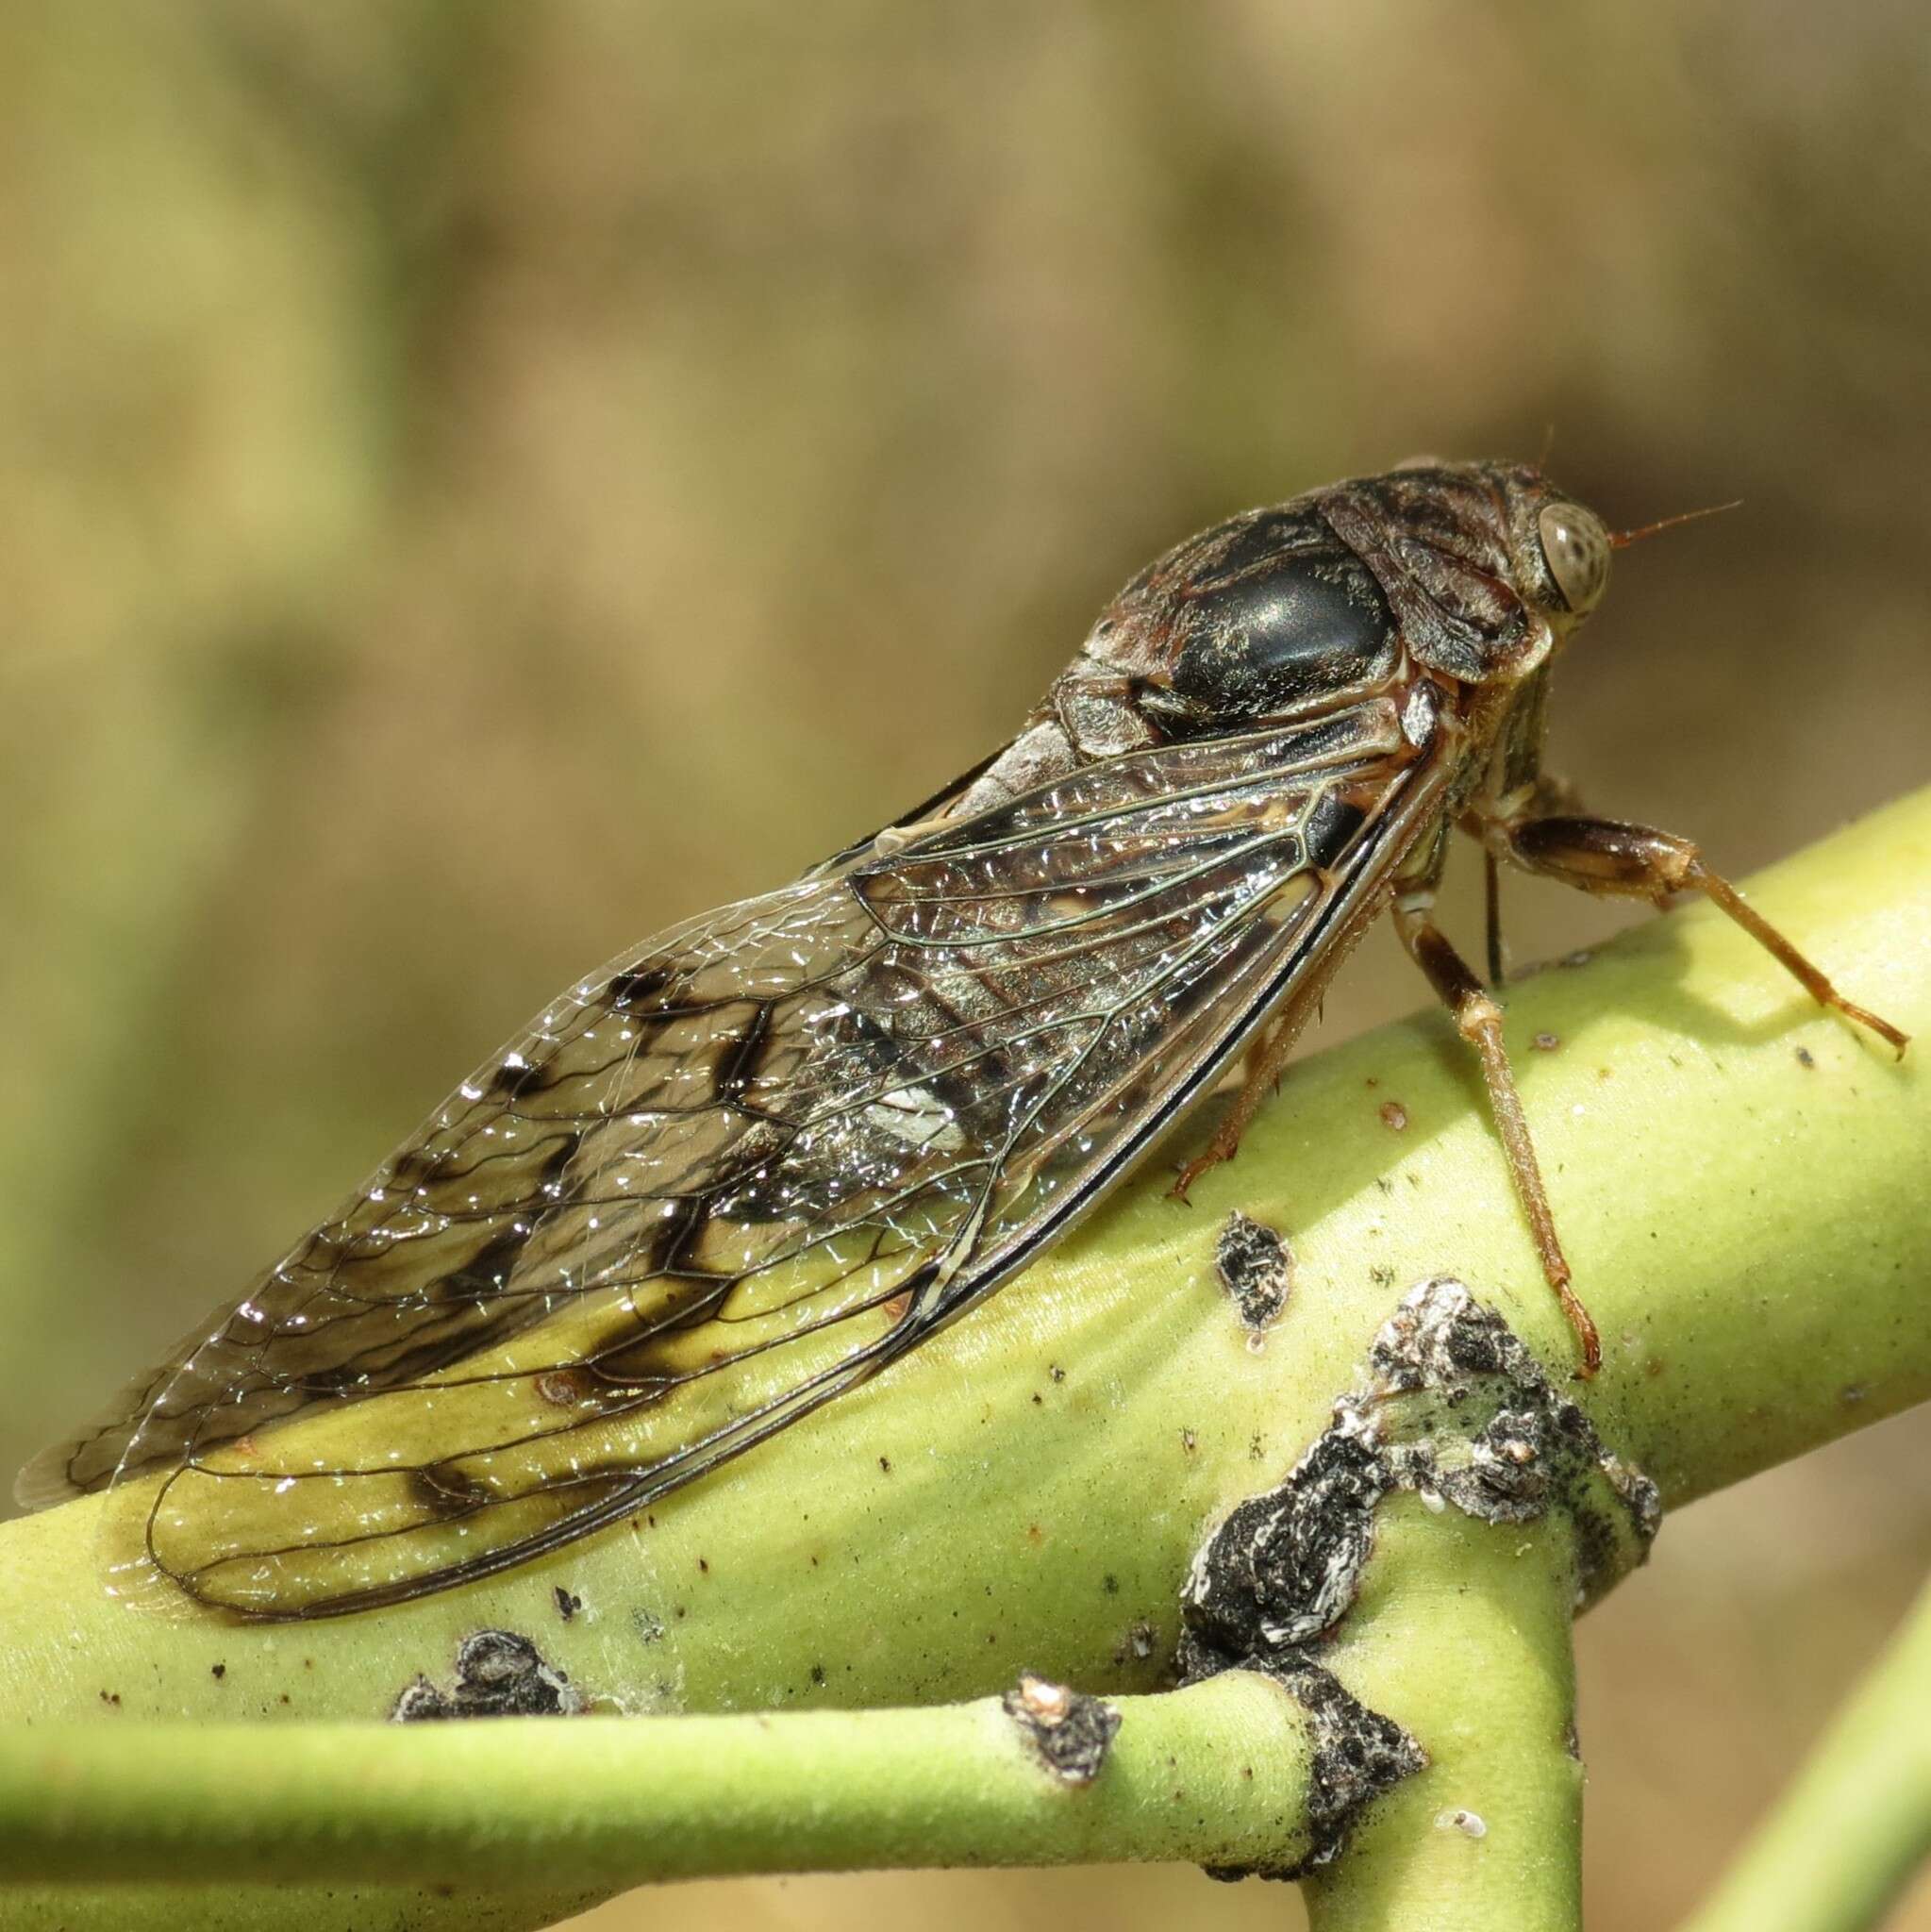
[[0, 0, 1931, 1932]]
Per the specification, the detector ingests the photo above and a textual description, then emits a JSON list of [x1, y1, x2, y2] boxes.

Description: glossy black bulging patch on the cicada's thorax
[[1174, 551, 1400, 717]]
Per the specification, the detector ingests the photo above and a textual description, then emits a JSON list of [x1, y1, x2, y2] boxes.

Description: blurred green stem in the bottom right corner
[[1686, 1568, 1931, 1932]]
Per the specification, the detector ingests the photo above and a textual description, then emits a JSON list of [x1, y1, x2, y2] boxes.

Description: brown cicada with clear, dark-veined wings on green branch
[[19, 461, 1904, 1617]]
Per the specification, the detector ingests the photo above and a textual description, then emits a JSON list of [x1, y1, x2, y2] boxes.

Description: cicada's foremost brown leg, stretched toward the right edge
[[1481, 813, 1909, 1058]]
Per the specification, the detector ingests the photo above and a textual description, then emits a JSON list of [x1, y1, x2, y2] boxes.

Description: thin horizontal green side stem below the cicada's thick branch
[[0, 1672, 1309, 1890]]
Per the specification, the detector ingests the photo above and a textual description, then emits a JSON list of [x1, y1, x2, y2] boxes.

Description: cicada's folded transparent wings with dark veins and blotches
[[22, 699, 1440, 1617]]
